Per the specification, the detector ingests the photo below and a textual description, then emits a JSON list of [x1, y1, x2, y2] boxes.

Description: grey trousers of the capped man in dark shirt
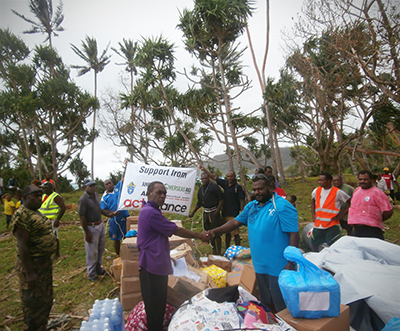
[[85, 222, 106, 279]]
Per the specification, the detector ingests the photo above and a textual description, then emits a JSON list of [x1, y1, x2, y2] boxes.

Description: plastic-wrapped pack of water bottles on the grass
[[79, 298, 125, 331]]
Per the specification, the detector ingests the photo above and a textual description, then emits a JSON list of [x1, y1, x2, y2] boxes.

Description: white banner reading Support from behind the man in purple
[[118, 163, 196, 216]]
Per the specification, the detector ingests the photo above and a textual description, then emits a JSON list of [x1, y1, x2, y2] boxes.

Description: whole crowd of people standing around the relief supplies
[[0, 165, 400, 330]]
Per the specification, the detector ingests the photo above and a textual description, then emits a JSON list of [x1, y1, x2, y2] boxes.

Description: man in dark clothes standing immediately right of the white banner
[[189, 172, 224, 255]]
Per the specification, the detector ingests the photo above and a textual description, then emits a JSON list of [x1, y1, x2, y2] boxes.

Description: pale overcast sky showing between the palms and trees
[[0, 0, 303, 179]]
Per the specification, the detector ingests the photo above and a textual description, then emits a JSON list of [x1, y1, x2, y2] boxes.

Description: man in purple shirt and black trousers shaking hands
[[137, 181, 209, 331]]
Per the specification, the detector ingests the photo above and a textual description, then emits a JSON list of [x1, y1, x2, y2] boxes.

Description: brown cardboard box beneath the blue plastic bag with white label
[[277, 305, 350, 331]]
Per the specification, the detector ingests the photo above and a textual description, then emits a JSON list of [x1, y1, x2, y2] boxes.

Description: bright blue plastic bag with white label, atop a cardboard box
[[278, 246, 340, 318]]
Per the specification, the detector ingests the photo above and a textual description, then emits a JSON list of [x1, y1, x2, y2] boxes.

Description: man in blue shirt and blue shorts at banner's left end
[[100, 179, 129, 256]]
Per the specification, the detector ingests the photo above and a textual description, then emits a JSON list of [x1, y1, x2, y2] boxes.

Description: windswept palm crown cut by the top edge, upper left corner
[[12, 0, 64, 46]]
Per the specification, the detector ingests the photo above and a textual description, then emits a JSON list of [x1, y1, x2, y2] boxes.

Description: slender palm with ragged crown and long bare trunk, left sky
[[71, 36, 111, 178]]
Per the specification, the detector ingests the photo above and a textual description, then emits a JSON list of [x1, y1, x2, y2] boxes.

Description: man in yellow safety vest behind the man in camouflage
[[39, 181, 65, 259]]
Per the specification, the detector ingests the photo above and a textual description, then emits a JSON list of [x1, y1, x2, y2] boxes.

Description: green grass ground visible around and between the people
[[0, 176, 400, 331]]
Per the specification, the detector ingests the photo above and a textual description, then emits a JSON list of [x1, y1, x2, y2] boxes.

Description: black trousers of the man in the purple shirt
[[139, 268, 168, 331]]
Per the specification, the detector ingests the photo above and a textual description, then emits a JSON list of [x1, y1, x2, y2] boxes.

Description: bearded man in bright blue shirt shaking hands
[[210, 174, 300, 312]]
